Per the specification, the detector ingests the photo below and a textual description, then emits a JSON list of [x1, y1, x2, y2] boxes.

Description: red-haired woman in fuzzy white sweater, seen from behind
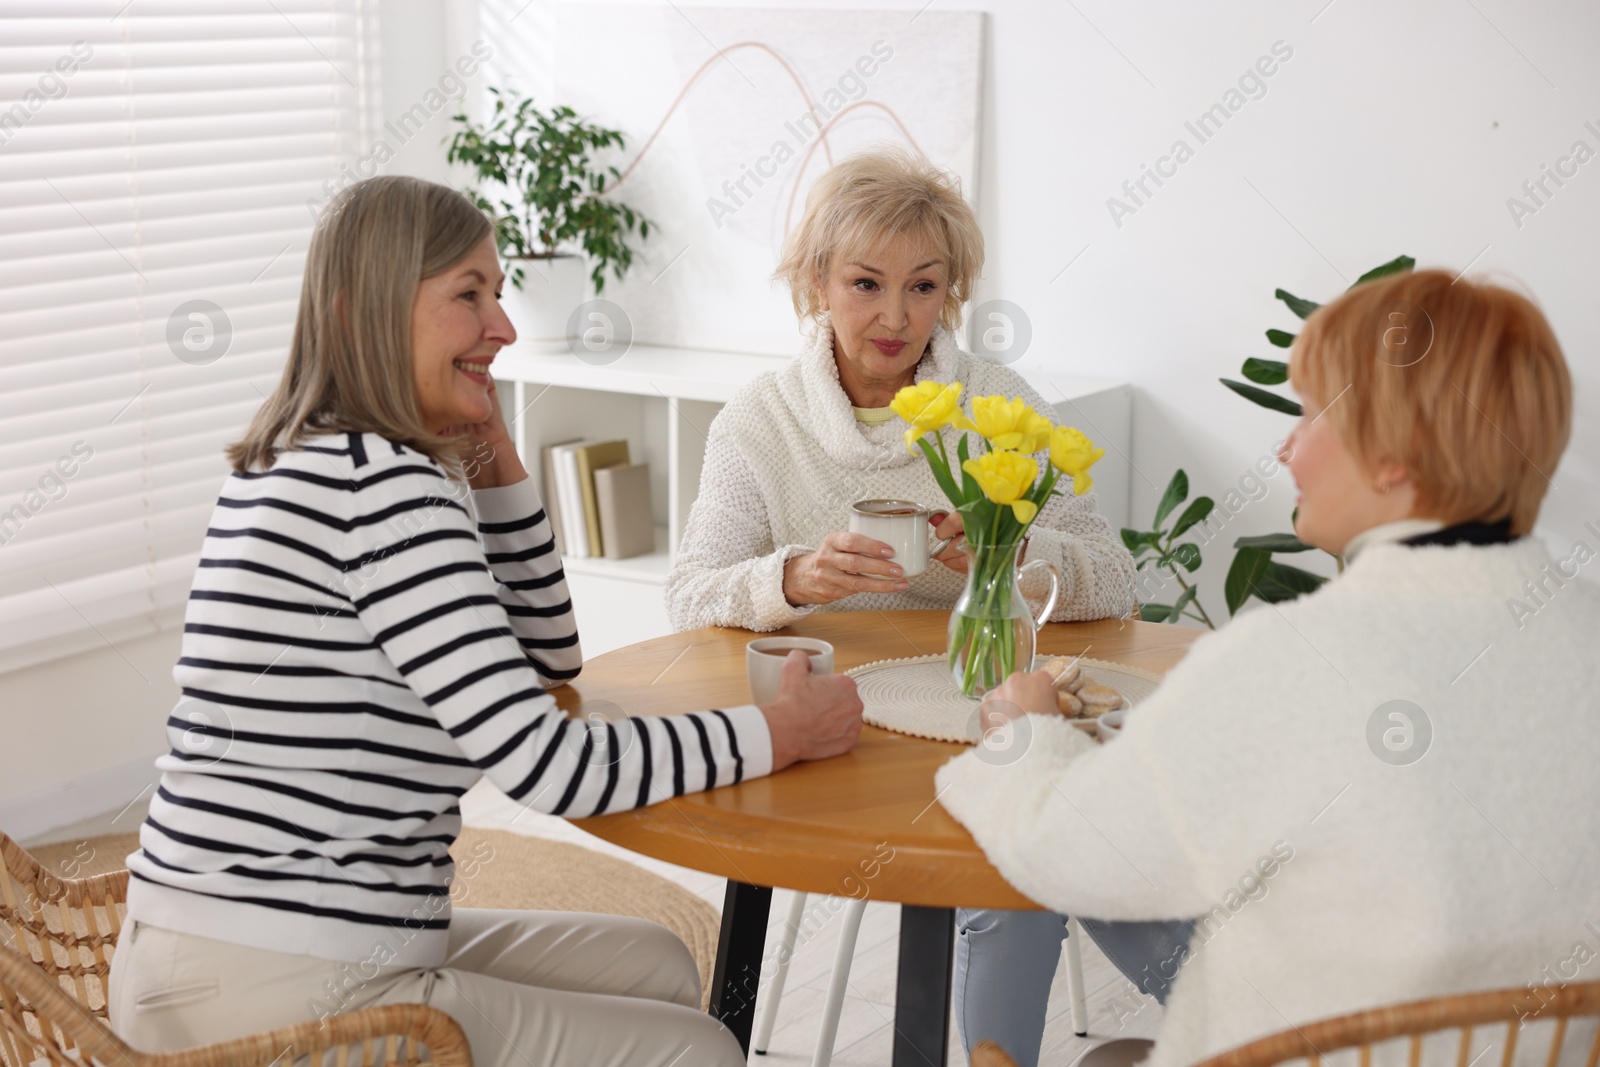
[[938, 270, 1600, 1067]]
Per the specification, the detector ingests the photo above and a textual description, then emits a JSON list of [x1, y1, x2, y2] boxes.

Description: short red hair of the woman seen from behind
[[1290, 270, 1573, 536]]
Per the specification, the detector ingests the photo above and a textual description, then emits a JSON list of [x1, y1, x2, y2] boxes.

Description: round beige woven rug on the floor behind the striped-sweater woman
[[27, 827, 722, 1008]]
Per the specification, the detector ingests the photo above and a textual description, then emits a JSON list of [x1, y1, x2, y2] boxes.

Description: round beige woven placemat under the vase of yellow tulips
[[845, 653, 1162, 744]]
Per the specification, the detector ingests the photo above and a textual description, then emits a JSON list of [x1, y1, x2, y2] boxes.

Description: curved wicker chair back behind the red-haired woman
[[973, 982, 1600, 1067]]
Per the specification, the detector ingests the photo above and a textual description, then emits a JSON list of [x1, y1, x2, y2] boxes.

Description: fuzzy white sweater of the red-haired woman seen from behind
[[938, 539, 1600, 1067]]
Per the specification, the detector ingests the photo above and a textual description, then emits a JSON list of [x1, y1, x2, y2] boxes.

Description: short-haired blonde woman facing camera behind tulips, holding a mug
[[666, 152, 1138, 1062]]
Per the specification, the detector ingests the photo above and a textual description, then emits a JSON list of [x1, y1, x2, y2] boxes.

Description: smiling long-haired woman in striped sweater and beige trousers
[[107, 178, 861, 1067]]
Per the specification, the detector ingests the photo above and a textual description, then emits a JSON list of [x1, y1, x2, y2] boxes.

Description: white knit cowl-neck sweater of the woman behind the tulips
[[667, 317, 1134, 630]]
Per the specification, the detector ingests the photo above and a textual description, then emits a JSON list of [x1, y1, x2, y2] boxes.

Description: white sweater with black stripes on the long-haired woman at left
[[128, 434, 771, 966]]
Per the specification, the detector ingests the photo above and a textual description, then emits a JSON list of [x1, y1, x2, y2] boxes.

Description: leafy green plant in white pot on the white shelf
[[445, 88, 651, 352]]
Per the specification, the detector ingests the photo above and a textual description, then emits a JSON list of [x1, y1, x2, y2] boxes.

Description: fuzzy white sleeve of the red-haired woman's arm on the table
[[934, 614, 1344, 920]]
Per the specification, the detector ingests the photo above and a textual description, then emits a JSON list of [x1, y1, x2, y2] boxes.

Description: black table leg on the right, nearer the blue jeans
[[891, 904, 955, 1067]]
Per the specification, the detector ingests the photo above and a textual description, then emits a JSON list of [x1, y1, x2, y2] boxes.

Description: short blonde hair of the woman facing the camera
[[773, 149, 984, 330]]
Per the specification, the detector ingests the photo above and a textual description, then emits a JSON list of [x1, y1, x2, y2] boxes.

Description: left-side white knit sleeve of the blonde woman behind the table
[[666, 413, 816, 630]]
